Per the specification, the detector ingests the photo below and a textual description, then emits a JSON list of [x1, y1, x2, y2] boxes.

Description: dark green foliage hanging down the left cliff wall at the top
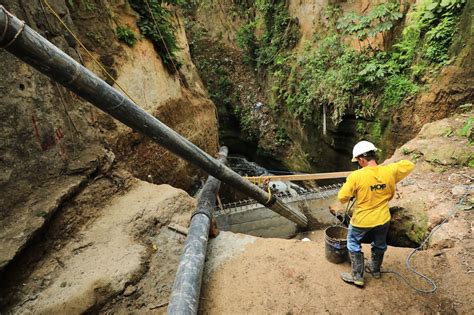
[[129, 0, 185, 73]]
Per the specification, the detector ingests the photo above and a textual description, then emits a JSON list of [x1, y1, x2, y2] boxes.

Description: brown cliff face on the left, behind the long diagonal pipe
[[0, 0, 218, 269]]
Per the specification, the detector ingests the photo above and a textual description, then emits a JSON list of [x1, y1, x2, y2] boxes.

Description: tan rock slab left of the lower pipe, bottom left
[[0, 177, 196, 314]]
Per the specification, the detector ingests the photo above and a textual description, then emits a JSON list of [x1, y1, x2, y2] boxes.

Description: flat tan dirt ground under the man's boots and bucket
[[200, 231, 474, 314]]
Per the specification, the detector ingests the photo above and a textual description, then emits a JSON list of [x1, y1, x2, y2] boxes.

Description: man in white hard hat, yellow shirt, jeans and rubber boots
[[337, 141, 414, 287]]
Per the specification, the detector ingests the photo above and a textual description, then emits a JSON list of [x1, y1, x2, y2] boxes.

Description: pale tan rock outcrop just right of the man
[[386, 111, 474, 248]]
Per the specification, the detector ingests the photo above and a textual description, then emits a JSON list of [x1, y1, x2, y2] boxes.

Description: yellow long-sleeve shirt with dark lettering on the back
[[337, 160, 415, 228]]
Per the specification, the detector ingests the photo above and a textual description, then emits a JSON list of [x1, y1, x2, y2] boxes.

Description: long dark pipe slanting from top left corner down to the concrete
[[0, 6, 308, 227]]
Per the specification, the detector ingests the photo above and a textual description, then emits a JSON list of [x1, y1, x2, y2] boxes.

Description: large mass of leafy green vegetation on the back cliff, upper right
[[264, 0, 465, 127]]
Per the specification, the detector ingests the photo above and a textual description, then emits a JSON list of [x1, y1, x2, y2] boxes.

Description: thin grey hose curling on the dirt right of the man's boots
[[381, 186, 472, 293]]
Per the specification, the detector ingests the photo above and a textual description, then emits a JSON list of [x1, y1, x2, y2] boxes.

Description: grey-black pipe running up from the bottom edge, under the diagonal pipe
[[168, 147, 228, 315]]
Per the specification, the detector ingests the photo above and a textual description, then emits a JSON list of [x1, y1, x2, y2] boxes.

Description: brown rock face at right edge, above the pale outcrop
[[383, 1, 474, 152]]
